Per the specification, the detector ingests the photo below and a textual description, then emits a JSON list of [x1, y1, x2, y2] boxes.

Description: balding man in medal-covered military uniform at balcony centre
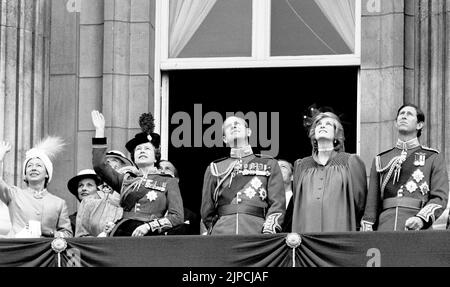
[[201, 116, 286, 235]]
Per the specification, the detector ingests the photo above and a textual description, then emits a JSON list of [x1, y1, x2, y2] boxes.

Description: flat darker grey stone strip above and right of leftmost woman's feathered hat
[[46, 0, 82, 214]]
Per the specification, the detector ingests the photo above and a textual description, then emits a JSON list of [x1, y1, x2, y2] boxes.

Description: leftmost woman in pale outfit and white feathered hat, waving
[[0, 137, 73, 237]]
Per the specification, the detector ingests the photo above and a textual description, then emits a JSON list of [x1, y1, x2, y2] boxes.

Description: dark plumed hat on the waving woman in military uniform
[[125, 113, 161, 156]]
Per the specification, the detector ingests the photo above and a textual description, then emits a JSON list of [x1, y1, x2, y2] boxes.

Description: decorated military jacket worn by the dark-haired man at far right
[[362, 145, 449, 231]]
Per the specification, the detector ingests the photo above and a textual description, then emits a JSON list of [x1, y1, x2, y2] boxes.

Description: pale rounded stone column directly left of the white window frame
[[103, 0, 155, 152]]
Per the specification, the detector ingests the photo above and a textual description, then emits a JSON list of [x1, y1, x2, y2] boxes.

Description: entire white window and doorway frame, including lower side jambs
[[154, 0, 361, 159]]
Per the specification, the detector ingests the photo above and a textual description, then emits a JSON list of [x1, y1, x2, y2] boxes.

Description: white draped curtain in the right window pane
[[315, 0, 356, 51]]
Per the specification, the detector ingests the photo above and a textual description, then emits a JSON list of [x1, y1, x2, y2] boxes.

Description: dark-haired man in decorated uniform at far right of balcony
[[361, 104, 449, 231]]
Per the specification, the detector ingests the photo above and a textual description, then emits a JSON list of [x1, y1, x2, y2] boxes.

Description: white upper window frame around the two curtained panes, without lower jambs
[[156, 0, 361, 71]]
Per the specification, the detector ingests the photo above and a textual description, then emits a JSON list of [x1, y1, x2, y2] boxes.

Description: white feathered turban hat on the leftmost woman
[[23, 136, 65, 182]]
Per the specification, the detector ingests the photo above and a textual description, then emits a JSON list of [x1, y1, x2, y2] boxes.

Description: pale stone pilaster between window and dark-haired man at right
[[361, 0, 405, 175]]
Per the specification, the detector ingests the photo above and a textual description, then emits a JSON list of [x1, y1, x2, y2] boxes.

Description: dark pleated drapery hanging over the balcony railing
[[0, 230, 450, 268]]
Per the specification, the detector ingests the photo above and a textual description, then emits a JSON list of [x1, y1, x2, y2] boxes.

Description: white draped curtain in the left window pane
[[169, 0, 217, 58]]
